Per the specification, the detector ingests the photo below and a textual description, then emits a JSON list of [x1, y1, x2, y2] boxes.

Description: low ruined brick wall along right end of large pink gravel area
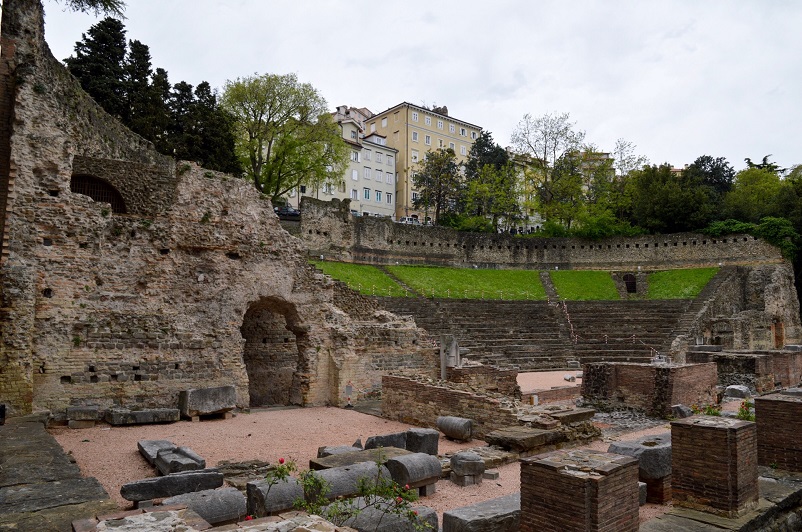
[[382, 375, 518, 438]]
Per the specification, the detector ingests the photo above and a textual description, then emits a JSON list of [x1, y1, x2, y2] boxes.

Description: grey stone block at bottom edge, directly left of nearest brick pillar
[[443, 493, 521, 532]]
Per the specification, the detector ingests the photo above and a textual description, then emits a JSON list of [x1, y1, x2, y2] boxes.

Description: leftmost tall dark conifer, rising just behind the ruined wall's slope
[[64, 17, 127, 119]]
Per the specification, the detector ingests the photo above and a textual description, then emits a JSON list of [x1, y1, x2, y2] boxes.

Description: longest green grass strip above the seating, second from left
[[387, 266, 546, 300]]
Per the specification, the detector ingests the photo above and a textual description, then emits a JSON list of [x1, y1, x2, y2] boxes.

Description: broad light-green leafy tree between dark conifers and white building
[[222, 74, 348, 199]]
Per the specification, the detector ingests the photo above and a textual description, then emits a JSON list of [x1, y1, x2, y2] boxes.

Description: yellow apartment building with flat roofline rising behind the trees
[[365, 102, 482, 221]]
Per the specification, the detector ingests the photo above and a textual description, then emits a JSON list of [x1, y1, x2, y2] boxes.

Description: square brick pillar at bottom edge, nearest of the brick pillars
[[520, 450, 639, 532]]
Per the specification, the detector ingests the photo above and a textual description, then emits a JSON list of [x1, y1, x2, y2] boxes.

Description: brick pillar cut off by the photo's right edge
[[755, 393, 802, 471]]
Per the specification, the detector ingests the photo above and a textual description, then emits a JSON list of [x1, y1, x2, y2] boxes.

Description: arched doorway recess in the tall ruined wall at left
[[240, 298, 308, 407]]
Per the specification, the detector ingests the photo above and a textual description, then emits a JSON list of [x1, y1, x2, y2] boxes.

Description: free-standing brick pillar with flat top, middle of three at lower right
[[671, 416, 758, 517]]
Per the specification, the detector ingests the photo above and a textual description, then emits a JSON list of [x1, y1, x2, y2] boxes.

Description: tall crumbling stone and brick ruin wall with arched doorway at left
[[0, 0, 434, 418]]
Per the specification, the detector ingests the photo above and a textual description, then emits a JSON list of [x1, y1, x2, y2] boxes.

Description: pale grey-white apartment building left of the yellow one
[[290, 105, 398, 218]]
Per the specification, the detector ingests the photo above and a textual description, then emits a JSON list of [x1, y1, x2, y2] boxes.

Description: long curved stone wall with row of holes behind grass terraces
[[300, 197, 783, 270]]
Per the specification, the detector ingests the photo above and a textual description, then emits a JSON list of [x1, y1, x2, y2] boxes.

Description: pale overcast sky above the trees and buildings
[[37, 0, 802, 169]]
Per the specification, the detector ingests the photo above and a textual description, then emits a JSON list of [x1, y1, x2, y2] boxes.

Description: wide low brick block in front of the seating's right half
[[582, 362, 718, 416]]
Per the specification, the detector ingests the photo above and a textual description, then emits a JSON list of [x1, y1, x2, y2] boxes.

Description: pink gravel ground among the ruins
[[50, 371, 669, 521]]
